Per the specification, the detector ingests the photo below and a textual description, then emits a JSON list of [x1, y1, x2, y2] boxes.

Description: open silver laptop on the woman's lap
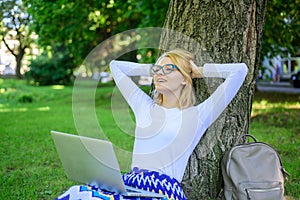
[[51, 131, 165, 198]]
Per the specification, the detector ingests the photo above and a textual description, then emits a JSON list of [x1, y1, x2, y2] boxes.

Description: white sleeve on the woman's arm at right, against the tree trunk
[[198, 63, 248, 129]]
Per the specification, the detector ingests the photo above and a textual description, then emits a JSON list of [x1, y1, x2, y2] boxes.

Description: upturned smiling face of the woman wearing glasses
[[153, 57, 186, 97]]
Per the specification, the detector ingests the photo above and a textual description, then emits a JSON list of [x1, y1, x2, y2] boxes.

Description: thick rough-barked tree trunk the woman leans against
[[160, 0, 267, 200]]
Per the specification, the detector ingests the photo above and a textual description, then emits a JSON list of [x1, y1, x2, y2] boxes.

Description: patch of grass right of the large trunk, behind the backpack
[[250, 92, 300, 199]]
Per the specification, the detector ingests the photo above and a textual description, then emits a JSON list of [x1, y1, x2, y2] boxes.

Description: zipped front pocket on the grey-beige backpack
[[241, 182, 284, 200]]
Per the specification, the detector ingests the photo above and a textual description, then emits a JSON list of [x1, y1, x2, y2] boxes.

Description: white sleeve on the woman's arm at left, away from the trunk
[[110, 60, 153, 118]]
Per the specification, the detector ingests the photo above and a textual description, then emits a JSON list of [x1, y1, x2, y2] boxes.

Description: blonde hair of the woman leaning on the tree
[[153, 49, 196, 109]]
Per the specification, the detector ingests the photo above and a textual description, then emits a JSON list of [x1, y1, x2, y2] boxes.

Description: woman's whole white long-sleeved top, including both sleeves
[[110, 61, 248, 182]]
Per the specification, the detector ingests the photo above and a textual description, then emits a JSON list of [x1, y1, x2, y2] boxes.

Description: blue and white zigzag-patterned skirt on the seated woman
[[57, 168, 186, 200]]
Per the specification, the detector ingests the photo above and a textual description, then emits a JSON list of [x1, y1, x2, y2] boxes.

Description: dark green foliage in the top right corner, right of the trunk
[[262, 0, 300, 57]]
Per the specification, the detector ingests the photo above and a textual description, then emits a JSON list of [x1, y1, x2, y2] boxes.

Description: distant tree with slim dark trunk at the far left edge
[[0, 0, 33, 78]]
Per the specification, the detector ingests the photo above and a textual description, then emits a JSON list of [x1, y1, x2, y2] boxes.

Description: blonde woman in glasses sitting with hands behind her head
[[55, 49, 247, 199]]
